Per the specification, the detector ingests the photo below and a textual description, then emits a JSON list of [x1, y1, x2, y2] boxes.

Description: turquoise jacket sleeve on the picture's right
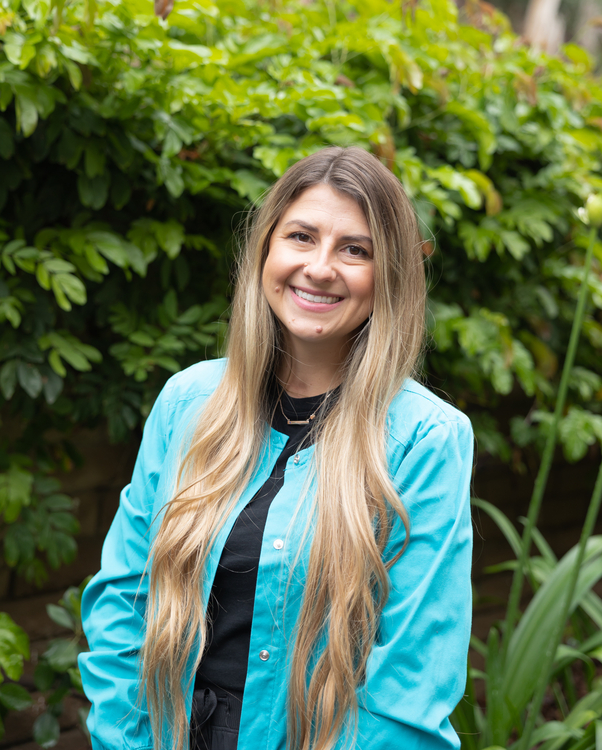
[[353, 415, 473, 750]]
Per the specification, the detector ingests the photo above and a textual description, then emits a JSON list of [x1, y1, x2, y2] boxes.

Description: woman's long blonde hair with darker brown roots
[[142, 147, 425, 750]]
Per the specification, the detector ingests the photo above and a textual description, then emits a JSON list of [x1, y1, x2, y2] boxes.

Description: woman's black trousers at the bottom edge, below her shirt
[[190, 688, 242, 750]]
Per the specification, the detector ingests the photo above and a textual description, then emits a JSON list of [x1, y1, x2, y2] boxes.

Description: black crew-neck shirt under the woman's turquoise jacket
[[195, 391, 338, 694]]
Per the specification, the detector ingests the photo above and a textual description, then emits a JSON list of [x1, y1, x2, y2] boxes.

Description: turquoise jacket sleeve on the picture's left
[[79, 385, 170, 750]]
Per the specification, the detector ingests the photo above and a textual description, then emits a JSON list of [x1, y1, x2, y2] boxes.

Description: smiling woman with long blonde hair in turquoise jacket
[[80, 148, 472, 750]]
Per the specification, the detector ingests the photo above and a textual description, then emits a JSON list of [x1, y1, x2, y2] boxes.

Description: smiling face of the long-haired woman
[[262, 185, 374, 356]]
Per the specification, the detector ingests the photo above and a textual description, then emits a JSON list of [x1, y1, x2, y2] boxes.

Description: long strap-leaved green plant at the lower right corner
[[452, 499, 602, 750]]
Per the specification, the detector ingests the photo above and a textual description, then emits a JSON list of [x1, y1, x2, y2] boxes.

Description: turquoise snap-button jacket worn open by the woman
[[79, 360, 473, 750]]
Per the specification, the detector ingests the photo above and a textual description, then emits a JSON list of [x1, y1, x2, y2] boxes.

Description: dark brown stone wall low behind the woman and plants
[[0, 430, 598, 750]]
